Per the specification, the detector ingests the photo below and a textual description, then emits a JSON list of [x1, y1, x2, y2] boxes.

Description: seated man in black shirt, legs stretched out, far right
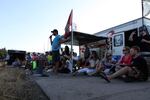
[[101, 46, 149, 82]]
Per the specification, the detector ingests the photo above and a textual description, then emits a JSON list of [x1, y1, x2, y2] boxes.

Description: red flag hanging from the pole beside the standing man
[[64, 10, 73, 38]]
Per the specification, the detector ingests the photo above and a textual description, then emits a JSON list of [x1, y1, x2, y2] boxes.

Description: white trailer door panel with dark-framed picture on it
[[112, 32, 125, 57]]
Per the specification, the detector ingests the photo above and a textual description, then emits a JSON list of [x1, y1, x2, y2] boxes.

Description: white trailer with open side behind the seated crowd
[[95, 18, 150, 59]]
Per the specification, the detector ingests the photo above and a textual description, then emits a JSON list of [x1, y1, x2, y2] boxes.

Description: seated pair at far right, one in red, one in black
[[100, 46, 149, 82]]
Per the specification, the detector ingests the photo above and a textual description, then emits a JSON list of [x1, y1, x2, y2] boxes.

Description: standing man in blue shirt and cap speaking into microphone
[[49, 29, 67, 72]]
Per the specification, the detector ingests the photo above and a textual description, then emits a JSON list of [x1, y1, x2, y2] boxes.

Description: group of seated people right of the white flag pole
[[73, 46, 149, 82]]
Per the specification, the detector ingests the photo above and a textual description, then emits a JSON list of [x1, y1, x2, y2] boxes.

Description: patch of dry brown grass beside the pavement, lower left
[[0, 67, 49, 100]]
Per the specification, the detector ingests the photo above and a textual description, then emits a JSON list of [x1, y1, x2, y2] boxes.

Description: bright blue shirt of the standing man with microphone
[[52, 35, 61, 51]]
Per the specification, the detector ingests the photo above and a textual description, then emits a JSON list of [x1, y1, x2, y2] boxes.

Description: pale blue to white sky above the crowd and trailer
[[0, 0, 141, 52]]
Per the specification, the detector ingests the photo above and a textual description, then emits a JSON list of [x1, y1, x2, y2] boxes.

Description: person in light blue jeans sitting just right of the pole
[[73, 51, 99, 76]]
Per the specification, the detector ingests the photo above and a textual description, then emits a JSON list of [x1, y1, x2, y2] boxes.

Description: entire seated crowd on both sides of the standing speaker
[[0, 46, 149, 82]]
